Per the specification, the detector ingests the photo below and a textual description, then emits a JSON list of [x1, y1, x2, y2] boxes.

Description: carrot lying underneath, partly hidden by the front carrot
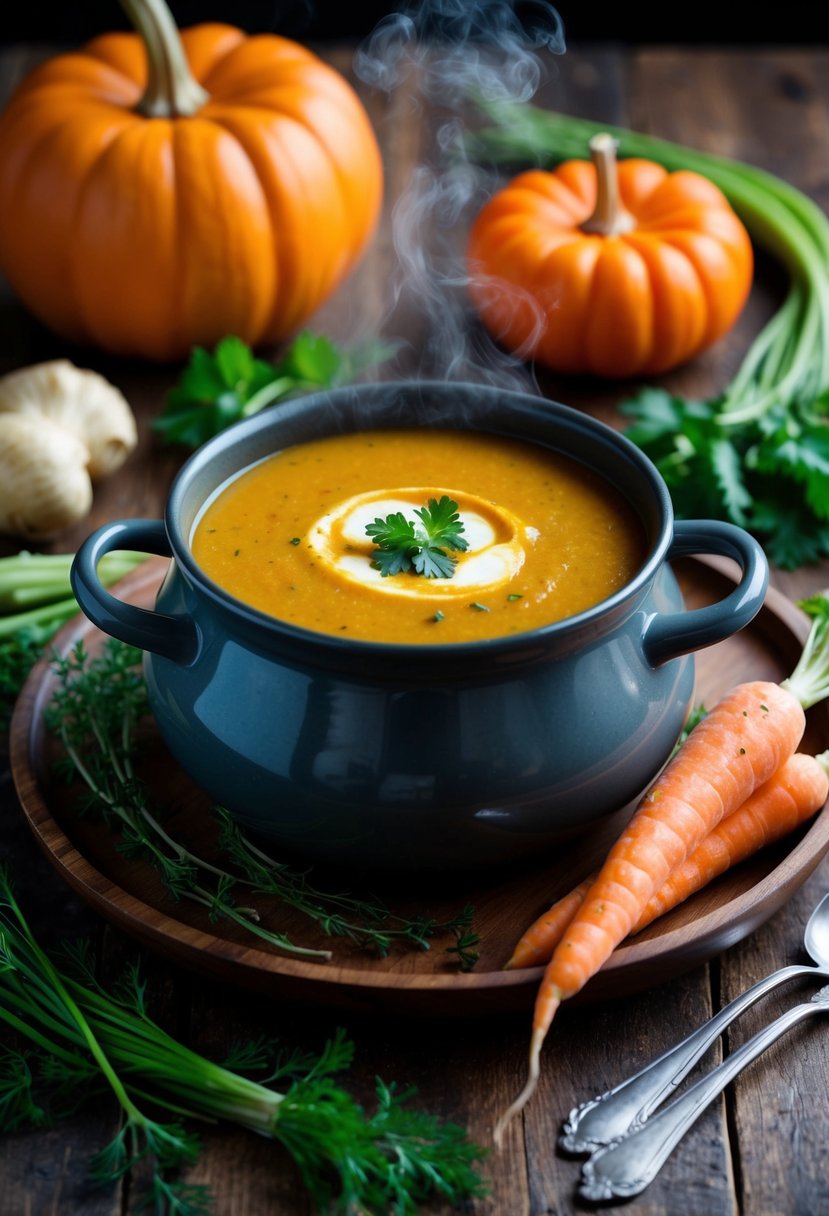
[[504, 751, 829, 970]]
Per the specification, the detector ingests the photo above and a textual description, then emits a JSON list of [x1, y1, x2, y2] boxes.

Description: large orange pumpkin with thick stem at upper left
[[0, 0, 382, 360]]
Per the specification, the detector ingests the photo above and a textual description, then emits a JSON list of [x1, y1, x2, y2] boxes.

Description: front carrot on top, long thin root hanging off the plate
[[495, 680, 806, 1143]]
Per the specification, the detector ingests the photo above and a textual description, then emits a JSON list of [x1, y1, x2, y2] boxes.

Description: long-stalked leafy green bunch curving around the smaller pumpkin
[[466, 101, 829, 569]]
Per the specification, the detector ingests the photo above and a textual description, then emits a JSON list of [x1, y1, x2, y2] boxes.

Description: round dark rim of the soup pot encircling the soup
[[164, 381, 673, 662]]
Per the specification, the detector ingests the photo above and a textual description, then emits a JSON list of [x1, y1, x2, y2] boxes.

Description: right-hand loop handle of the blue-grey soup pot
[[643, 519, 768, 666]]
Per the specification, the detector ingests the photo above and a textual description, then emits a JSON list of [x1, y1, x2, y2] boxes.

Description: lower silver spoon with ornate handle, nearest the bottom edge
[[580, 987, 829, 1200]]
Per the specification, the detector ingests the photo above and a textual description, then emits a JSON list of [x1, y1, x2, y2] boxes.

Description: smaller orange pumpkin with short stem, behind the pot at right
[[468, 135, 754, 378]]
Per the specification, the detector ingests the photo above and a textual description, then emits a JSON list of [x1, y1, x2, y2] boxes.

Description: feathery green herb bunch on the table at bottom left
[[0, 868, 484, 1216]]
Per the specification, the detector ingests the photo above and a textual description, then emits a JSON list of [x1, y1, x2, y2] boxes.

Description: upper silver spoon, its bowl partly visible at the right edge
[[559, 894, 829, 1153]]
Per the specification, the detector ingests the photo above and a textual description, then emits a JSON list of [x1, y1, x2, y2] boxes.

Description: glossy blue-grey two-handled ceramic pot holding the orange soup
[[73, 382, 768, 871]]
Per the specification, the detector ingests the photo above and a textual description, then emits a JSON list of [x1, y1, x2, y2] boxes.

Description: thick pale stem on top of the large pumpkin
[[120, 0, 209, 118]]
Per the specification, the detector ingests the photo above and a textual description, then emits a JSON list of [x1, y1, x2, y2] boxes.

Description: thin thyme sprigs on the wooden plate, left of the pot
[[46, 638, 473, 969]]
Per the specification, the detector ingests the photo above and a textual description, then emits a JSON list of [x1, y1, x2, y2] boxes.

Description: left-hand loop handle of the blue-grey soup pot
[[71, 519, 201, 666]]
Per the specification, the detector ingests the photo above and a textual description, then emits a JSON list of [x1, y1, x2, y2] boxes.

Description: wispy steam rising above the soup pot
[[354, 0, 564, 389]]
